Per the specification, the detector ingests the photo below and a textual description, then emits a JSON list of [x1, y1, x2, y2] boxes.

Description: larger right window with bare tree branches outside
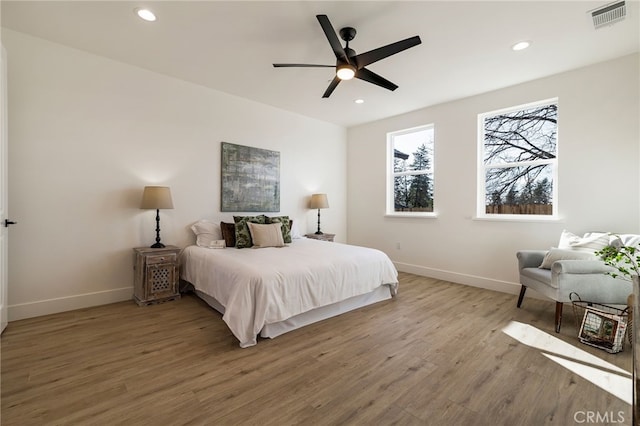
[[477, 99, 558, 218]]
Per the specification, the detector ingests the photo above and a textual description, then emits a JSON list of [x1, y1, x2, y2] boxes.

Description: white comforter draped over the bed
[[181, 238, 398, 347]]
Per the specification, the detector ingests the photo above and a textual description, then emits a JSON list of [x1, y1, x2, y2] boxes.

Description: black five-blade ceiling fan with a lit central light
[[273, 15, 422, 98]]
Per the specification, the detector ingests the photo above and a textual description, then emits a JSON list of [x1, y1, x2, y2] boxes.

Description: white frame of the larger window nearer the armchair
[[474, 97, 560, 222]]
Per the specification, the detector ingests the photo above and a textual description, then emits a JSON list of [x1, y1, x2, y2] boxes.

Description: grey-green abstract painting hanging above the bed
[[220, 142, 280, 212]]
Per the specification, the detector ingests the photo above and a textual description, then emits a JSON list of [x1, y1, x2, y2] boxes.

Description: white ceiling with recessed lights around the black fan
[[0, 0, 640, 127]]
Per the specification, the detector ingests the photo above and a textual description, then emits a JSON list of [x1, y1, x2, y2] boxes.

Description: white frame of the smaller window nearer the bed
[[385, 123, 437, 218]]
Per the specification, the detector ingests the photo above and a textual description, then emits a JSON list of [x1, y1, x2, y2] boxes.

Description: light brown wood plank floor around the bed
[[0, 273, 631, 426]]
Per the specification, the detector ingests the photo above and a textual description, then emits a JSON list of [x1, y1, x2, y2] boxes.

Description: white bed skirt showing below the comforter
[[195, 285, 392, 339]]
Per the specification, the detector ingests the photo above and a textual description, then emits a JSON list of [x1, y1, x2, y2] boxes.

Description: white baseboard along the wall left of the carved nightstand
[[9, 287, 133, 321]]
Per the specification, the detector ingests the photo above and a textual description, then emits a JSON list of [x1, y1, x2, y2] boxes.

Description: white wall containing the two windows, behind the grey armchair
[[347, 54, 640, 292]]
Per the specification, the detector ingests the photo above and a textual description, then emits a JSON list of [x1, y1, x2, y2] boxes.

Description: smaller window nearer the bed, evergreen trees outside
[[387, 125, 434, 215]]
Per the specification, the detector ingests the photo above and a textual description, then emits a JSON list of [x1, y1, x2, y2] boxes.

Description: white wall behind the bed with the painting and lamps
[[2, 29, 346, 320]]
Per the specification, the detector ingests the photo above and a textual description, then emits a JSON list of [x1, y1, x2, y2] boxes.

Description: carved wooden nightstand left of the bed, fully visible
[[133, 246, 180, 306]]
